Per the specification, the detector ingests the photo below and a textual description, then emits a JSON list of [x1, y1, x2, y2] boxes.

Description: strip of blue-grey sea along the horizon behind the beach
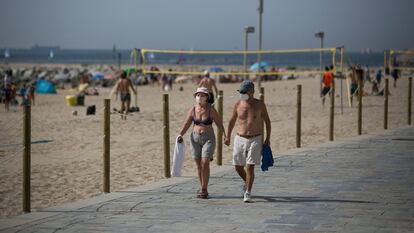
[[0, 47, 384, 67]]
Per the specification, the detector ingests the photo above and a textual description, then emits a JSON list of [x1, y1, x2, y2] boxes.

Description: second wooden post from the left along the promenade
[[103, 99, 111, 193]]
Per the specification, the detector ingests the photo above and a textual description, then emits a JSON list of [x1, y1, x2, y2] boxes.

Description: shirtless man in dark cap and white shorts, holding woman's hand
[[224, 80, 271, 202]]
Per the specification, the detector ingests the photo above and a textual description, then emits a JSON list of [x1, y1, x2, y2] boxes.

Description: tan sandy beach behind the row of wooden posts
[[0, 69, 408, 218]]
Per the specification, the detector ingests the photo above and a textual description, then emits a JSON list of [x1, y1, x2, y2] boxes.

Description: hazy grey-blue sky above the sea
[[0, 0, 414, 51]]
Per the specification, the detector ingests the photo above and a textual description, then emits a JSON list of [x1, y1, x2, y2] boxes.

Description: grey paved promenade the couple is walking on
[[0, 127, 414, 233]]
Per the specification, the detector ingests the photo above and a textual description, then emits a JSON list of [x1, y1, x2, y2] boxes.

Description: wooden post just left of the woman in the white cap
[[162, 94, 171, 178]]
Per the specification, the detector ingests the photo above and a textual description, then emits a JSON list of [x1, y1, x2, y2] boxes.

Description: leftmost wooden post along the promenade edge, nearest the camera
[[23, 105, 31, 213]]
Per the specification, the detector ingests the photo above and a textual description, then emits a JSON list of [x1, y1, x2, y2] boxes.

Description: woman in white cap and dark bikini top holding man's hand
[[177, 87, 226, 199]]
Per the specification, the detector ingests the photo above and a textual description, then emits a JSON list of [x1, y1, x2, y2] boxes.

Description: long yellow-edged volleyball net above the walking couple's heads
[[131, 48, 344, 76]]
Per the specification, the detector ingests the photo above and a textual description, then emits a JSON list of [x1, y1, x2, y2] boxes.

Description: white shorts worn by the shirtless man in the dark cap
[[233, 135, 263, 166]]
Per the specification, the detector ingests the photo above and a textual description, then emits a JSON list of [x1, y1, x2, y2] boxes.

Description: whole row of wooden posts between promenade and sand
[[19, 77, 412, 212]]
